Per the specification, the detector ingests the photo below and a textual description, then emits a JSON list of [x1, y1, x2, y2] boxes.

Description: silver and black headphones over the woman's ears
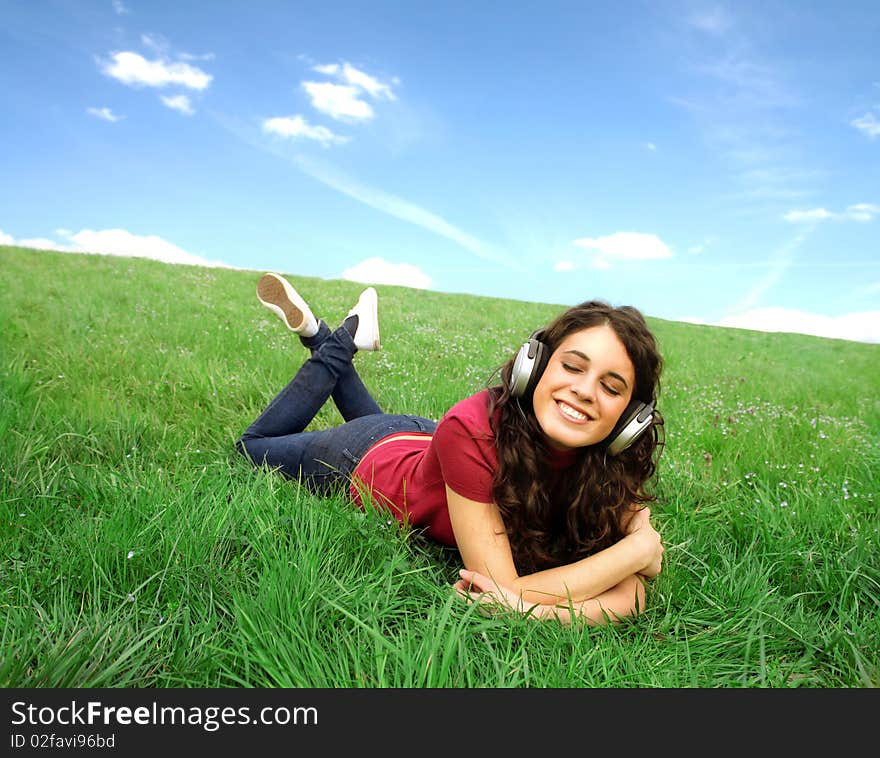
[[507, 329, 654, 455]]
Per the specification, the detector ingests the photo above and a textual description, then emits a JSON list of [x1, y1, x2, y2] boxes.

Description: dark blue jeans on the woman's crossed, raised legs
[[236, 321, 437, 495]]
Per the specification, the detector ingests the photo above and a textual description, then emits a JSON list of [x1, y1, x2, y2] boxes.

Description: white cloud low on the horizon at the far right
[[714, 307, 880, 342]]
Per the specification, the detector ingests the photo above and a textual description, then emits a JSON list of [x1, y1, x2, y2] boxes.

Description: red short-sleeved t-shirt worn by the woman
[[350, 390, 575, 547]]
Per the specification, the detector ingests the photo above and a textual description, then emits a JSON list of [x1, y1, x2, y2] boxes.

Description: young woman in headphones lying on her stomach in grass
[[237, 274, 663, 624]]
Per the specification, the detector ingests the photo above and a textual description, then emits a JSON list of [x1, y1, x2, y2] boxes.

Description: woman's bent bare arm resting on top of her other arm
[[446, 487, 663, 606]]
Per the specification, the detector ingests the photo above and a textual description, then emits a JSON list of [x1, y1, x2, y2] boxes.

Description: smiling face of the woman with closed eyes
[[532, 326, 635, 450]]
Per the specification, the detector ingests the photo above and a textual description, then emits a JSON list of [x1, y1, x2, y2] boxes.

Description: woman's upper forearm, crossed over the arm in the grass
[[510, 534, 646, 606]]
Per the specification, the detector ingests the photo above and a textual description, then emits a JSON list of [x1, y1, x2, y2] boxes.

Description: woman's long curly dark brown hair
[[489, 300, 663, 574]]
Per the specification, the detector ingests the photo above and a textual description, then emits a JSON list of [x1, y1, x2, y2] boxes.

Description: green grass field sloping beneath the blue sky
[[0, 247, 880, 688]]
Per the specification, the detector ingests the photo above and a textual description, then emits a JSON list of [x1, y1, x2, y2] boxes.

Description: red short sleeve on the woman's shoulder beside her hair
[[432, 392, 498, 503]]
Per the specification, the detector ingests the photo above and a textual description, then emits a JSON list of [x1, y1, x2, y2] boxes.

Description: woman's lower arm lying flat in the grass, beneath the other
[[454, 569, 645, 625]]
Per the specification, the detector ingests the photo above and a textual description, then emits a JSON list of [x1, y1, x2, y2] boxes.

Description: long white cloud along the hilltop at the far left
[[0, 229, 234, 268]]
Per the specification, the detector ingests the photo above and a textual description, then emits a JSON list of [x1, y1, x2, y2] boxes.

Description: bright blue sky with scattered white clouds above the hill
[[0, 0, 880, 342]]
